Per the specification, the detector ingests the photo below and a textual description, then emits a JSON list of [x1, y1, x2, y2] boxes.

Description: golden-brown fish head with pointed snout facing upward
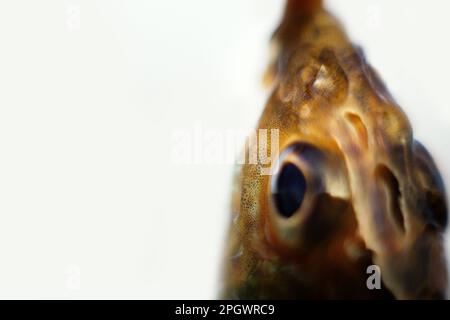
[[219, 0, 448, 299]]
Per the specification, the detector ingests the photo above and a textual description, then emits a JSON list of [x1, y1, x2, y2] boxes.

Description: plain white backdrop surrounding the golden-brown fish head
[[0, 0, 450, 299]]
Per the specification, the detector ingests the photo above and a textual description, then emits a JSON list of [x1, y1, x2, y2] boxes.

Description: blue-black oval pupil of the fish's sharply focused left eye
[[272, 163, 306, 218]]
